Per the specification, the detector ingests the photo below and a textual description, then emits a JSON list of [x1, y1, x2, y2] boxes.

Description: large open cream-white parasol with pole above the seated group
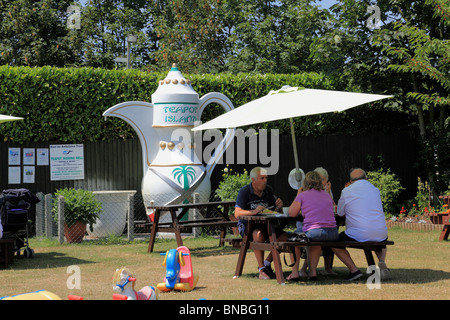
[[192, 86, 392, 188]]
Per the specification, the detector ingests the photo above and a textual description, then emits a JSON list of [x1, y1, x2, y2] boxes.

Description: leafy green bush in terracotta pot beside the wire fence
[[52, 188, 102, 243]]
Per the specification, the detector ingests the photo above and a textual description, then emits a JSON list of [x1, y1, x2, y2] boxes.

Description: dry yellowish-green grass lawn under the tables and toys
[[0, 228, 450, 300]]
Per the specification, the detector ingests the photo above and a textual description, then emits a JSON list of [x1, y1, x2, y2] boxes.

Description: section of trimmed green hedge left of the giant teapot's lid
[[0, 66, 160, 143]]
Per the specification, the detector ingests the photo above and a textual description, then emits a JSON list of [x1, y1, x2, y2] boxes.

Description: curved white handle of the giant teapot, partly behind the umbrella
[[200, 92, 236, 176]]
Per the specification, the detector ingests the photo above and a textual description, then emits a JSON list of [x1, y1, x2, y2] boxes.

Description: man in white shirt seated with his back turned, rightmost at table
[[333, 168, 389, 280]]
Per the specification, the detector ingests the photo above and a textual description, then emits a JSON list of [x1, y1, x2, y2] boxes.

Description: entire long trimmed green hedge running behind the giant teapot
[[0, 66, 410, 143]]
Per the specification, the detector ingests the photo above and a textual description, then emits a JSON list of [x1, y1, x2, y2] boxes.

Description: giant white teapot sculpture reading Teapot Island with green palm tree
[[103, 64, 235, 221]]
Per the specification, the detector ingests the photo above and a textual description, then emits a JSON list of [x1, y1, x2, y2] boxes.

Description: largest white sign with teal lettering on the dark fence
[[50, 144, 84, 181]]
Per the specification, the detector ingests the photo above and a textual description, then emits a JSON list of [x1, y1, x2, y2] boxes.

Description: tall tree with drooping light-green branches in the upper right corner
[[304, 0, 450, 199]]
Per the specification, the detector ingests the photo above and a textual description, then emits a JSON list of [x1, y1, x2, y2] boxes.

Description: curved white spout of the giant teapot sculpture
[[103, 101, 159, 175]]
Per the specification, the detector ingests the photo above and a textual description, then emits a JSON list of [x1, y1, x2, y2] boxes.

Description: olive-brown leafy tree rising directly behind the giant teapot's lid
[[149, 0, 237, 73]]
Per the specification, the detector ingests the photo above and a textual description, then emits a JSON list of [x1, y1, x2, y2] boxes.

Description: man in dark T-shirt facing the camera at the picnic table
[[234, 167, 283, 280]]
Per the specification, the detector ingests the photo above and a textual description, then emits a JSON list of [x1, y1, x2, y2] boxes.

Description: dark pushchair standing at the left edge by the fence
[[0, 188, 40, 258]]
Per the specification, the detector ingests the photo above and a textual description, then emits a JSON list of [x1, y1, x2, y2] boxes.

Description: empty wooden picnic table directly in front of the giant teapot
[[147, 201, 237, 252]]
